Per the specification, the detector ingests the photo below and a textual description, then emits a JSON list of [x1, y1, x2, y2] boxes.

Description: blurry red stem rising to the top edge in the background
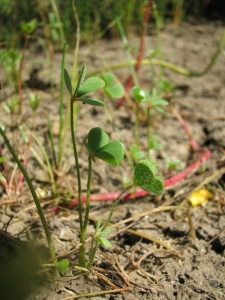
[[116, 0, 152, 107]]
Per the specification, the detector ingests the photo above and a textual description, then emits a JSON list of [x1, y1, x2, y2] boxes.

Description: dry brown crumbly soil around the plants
[[0, 23, 225, 300]]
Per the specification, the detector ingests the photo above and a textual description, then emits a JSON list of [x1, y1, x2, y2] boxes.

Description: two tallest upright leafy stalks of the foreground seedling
[[64, 65, 124, 268]]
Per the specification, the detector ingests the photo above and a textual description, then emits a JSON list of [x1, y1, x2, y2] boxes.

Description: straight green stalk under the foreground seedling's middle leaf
[[79, 155, 92, 268]]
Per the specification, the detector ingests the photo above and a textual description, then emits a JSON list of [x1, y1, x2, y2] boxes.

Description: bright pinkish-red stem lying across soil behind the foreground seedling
[[68, 149, 211, 207]]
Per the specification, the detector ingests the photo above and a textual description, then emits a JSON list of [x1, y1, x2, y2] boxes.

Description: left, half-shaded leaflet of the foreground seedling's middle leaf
[[88, 127, 109, 155]]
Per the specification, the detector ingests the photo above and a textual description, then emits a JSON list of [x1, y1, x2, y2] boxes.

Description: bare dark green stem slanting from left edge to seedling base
[[0, 127, 57, 265]]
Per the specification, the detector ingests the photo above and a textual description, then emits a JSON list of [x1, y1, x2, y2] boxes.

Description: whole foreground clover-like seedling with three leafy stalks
[[64, 65, 163, 268]]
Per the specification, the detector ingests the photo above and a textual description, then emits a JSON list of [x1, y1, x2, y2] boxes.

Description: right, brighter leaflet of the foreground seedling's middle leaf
[[95, 141, 124, 166]]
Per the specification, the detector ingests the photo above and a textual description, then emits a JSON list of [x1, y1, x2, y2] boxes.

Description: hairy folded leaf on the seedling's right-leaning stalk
[[133, 160, 164, 195]]
